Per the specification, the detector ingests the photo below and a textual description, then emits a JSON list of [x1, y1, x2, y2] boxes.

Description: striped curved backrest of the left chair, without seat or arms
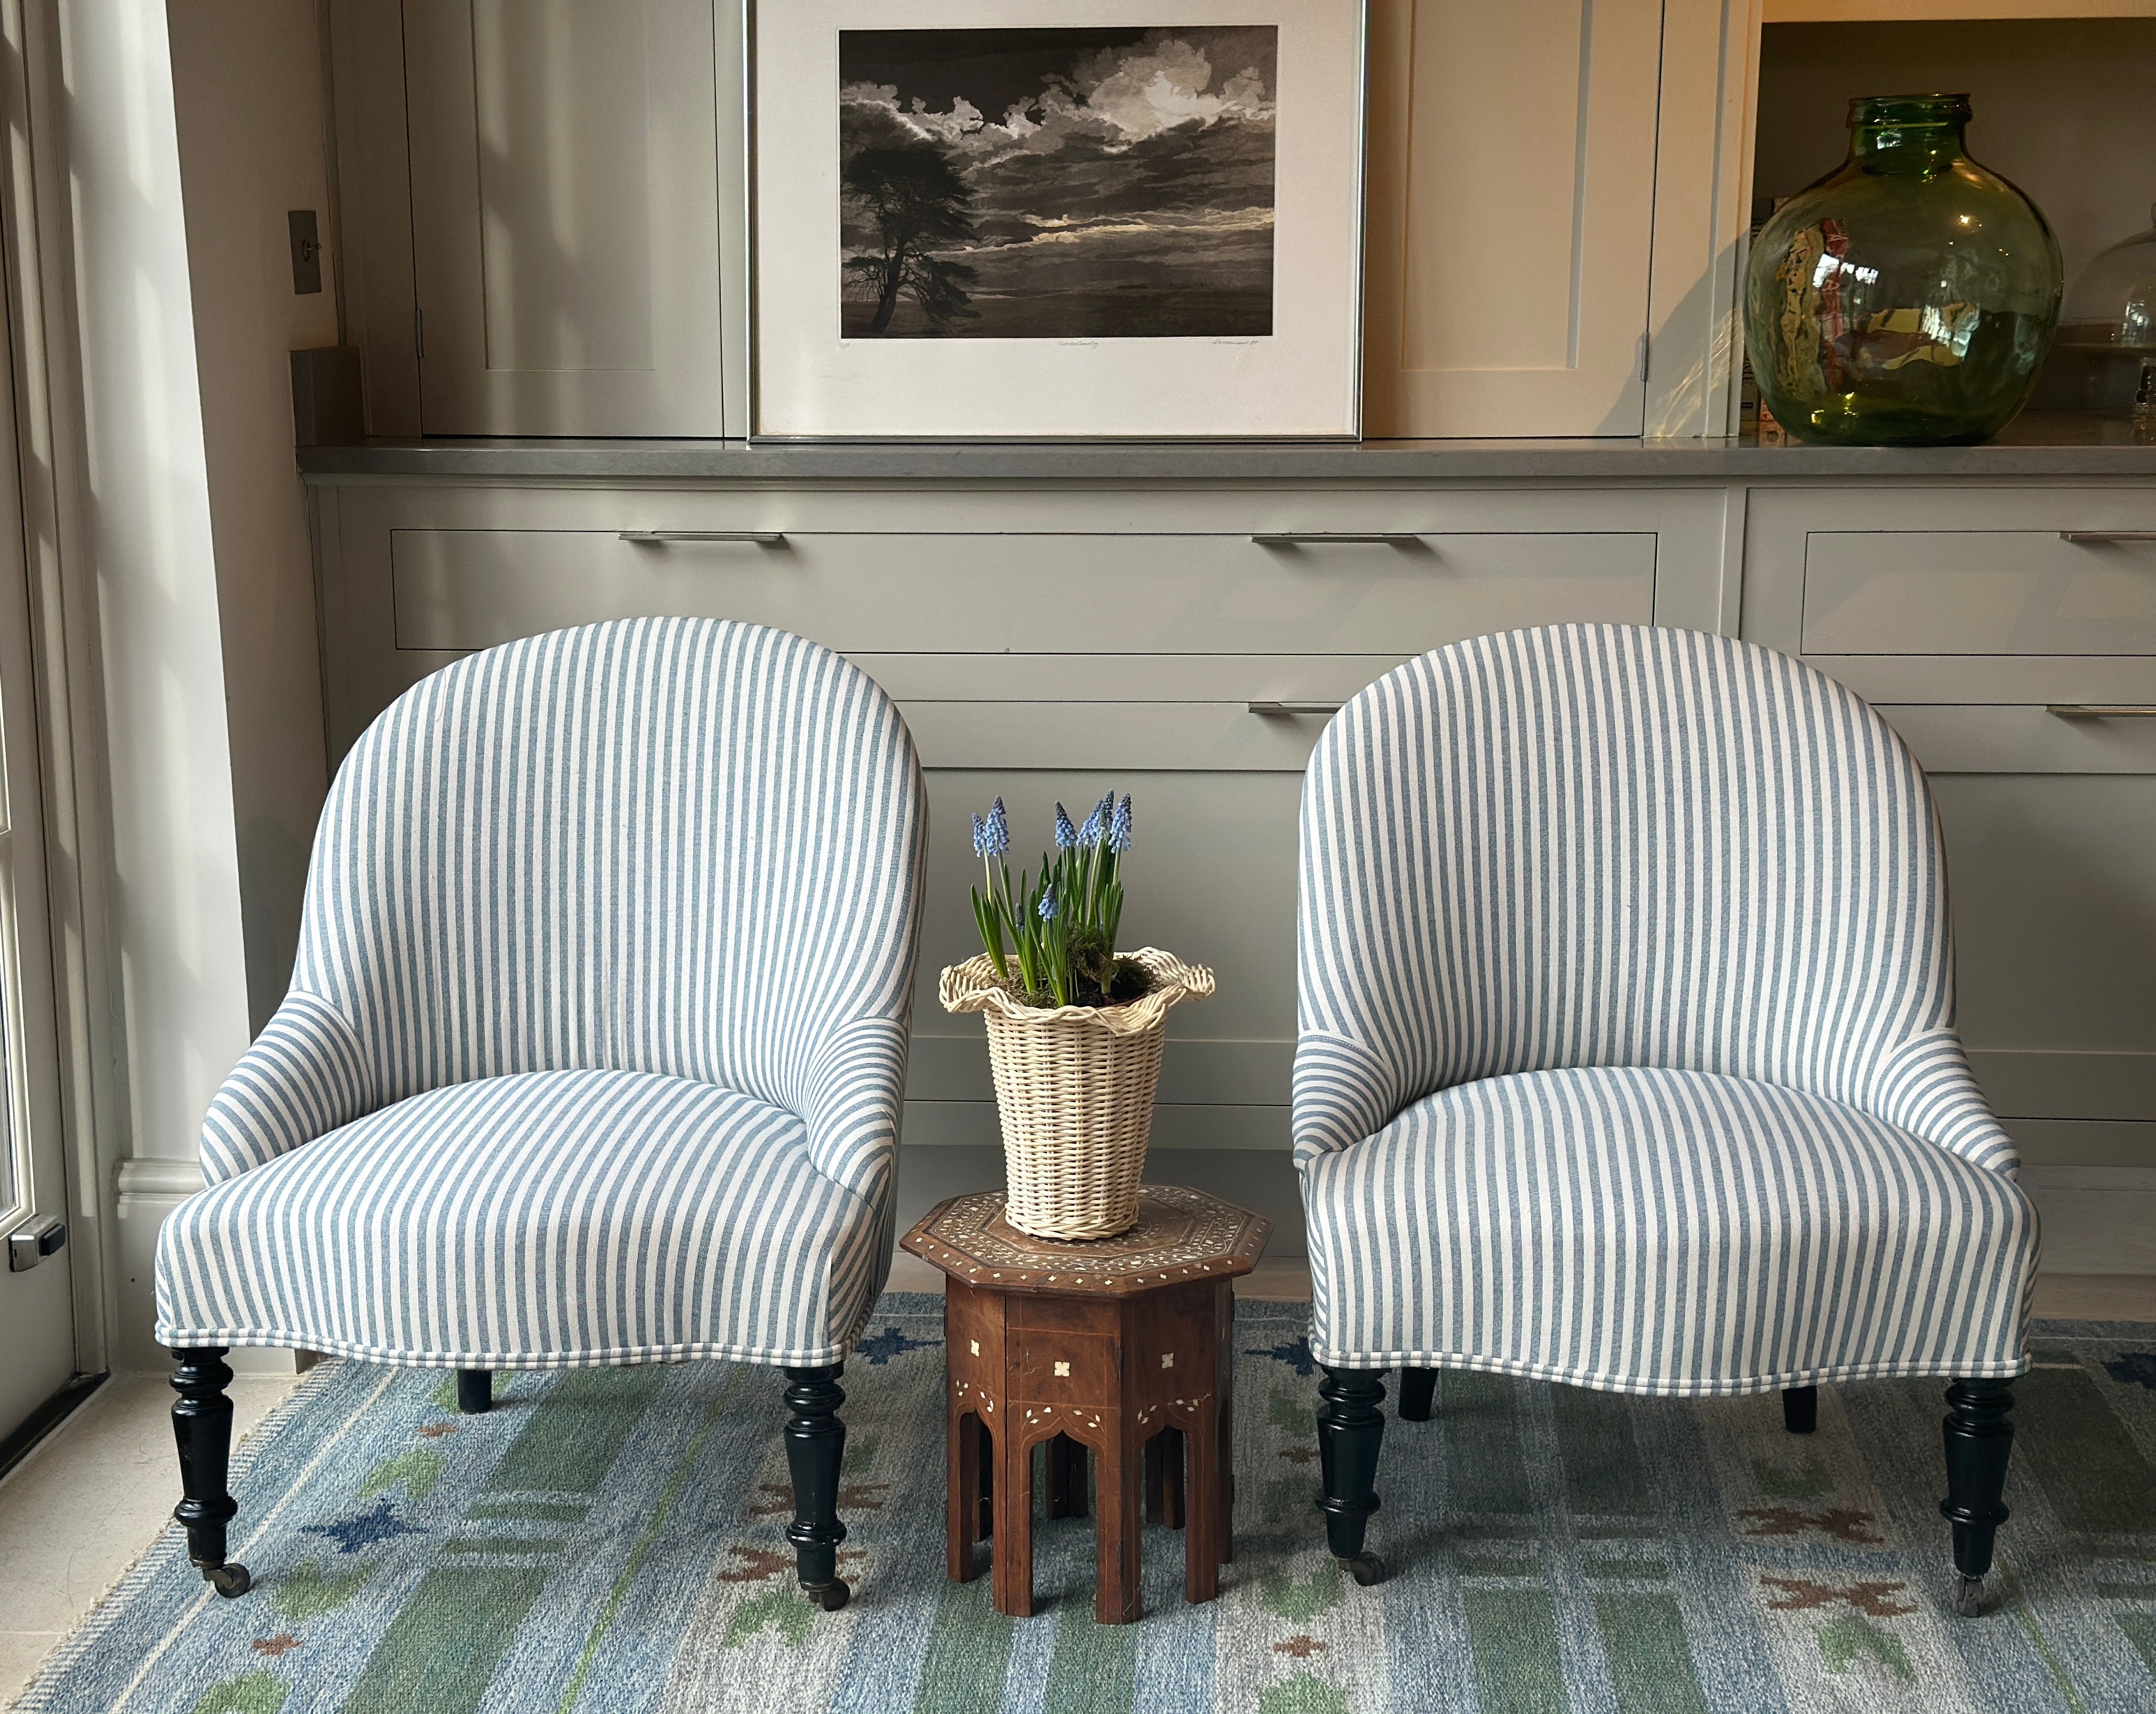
[[293, 619, 925, 1112]]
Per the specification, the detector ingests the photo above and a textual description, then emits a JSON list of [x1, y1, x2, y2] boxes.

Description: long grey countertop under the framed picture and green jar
[[297, 412, 2156, 485]]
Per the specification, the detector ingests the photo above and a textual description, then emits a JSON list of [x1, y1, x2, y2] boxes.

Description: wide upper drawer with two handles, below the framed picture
[[390, 528, 1656, 660]]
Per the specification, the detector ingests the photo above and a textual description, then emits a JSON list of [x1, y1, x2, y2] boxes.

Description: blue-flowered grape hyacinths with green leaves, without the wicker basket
[[972, 791, 1151, 1007]]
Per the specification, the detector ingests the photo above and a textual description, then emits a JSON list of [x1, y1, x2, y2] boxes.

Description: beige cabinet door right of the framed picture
[[1364, 0, 1662, 435]]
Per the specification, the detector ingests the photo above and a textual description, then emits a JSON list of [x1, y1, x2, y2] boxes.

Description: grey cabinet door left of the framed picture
[[403, 0, 723, 435]]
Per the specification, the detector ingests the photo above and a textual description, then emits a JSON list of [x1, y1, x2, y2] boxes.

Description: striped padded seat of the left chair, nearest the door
[[158, 1072, 890, 1369]]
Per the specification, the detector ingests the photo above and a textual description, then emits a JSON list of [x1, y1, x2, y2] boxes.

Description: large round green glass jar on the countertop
[[1744, 95, 2063, 446]]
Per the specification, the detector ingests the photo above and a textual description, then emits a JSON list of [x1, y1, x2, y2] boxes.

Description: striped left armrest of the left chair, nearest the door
[[202, 992, 375, 1184]]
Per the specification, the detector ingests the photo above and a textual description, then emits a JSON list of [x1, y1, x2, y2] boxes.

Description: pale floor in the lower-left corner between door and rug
[[0, 1375, 300, 1708]]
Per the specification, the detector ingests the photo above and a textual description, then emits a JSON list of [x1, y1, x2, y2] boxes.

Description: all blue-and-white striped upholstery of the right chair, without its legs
[[1294, 625, 2038, 1395]]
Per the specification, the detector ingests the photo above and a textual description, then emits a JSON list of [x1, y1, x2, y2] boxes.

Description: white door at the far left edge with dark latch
[[0, 224, 75, 1440]]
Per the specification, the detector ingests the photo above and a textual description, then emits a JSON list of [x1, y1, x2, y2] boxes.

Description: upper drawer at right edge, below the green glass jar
[[1805, 530, 2156, 656]]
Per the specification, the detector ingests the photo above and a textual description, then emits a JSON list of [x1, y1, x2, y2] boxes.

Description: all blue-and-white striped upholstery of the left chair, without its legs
[[158, 619, 927, 1369]]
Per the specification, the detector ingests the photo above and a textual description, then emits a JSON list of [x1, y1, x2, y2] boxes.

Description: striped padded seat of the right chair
[[1305, 1067, 2038, 1395]]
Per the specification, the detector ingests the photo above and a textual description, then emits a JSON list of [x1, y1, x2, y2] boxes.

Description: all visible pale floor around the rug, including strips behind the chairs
[[0, 1255, 2156, 1708]]
